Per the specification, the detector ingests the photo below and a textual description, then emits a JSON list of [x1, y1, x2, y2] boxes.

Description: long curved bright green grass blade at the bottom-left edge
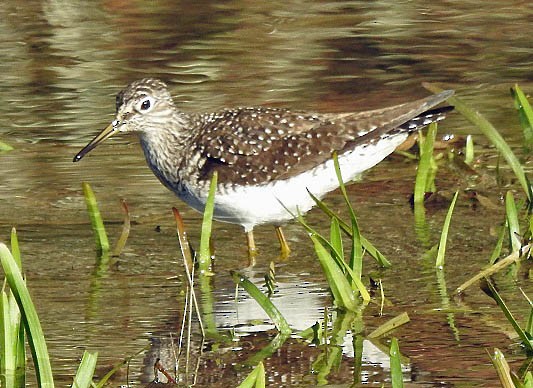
[[0, 243, 54, 388]]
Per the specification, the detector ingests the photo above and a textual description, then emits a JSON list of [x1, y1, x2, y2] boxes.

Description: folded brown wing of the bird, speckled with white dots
[[196, 92, 451, 185]]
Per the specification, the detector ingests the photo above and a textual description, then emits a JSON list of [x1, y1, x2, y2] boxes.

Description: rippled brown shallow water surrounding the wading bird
[[0, 0, 533, 386]]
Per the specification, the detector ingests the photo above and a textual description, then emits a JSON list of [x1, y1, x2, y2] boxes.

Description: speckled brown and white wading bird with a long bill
[[73, 78, 454, 258]]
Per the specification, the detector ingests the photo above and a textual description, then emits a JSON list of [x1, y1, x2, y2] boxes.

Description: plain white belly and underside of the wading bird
[[180, 134, 407, 231]]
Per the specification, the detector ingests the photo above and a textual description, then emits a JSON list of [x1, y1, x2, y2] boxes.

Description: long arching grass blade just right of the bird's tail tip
[[424, 84, 533, 202]]
